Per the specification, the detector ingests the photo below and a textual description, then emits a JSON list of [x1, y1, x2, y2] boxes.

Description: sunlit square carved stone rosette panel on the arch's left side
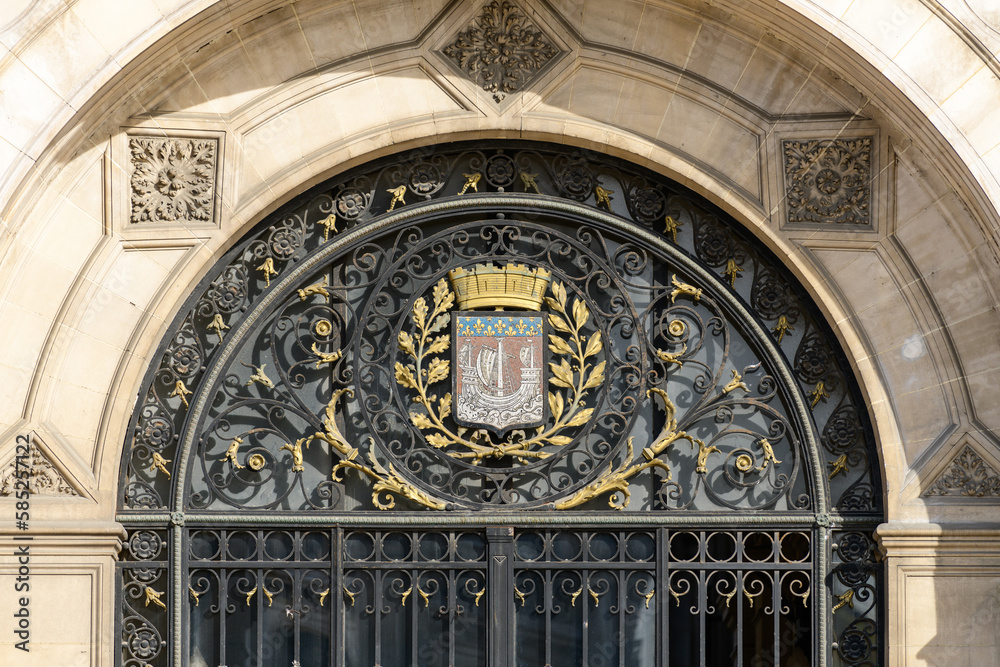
[[129, 136, 219, 223]]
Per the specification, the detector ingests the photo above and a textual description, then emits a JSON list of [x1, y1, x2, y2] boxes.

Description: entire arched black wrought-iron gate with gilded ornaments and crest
[[119, 143, 881, 667]]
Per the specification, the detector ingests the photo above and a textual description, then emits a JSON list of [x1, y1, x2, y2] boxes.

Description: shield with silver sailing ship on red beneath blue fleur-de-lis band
[[453, 312, 547, 434]]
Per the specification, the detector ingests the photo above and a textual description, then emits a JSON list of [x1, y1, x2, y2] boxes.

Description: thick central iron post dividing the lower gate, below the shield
[[486, 526, 515, 667]]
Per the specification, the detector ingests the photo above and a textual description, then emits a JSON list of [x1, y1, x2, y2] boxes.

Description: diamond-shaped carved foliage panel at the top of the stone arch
[[444, 0, 559, 103]]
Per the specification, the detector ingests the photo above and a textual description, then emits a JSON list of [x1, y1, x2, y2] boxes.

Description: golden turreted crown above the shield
[[448, 264, 552, 310]]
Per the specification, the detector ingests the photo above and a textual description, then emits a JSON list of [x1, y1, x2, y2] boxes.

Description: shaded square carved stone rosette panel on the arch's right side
[[782, 137, 872, 226]]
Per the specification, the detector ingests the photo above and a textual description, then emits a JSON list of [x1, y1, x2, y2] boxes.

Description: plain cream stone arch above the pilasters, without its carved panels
[[0, 0, 1000, 664]]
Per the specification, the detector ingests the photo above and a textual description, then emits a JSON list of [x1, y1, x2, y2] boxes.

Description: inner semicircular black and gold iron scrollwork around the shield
[[172, 214, 811, 509]]
